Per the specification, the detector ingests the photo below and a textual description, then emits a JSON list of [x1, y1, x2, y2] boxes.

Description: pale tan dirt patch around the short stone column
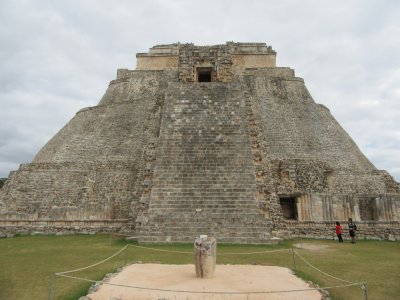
[[87, 264, 321, 300]]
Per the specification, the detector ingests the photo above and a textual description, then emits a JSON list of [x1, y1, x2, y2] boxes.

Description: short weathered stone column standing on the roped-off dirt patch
[[194, 235, 217, 278]]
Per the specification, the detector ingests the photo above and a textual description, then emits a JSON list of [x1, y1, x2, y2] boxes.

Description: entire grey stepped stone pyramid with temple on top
[[0, 42, 400, 243]]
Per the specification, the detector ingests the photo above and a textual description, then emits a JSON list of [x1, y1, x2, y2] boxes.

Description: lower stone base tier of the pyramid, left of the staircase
[[0, 161, 138, 220]]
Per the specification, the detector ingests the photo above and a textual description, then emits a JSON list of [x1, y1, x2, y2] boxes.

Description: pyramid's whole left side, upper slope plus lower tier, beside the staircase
[[0, 70, 177, 225]]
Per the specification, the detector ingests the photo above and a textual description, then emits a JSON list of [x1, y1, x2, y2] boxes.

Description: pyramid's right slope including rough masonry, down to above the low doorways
[[243, 69, 387, 199]]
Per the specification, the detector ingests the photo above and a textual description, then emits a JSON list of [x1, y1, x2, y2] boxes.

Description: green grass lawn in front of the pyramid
[[0, 235, 400, 300]]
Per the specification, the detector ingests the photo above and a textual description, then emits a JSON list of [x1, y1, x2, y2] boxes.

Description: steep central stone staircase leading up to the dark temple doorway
[[138, 82, 271, 243]]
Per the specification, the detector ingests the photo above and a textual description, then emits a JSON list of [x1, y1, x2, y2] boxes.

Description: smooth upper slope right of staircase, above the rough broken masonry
[[245, 71, 375, 172]]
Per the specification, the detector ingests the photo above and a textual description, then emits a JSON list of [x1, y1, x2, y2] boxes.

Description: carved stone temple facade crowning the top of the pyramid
[[136, 42, 276, 82]]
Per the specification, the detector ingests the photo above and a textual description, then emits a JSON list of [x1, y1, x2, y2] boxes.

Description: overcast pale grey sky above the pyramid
[[0, 0, 400, 181]]
